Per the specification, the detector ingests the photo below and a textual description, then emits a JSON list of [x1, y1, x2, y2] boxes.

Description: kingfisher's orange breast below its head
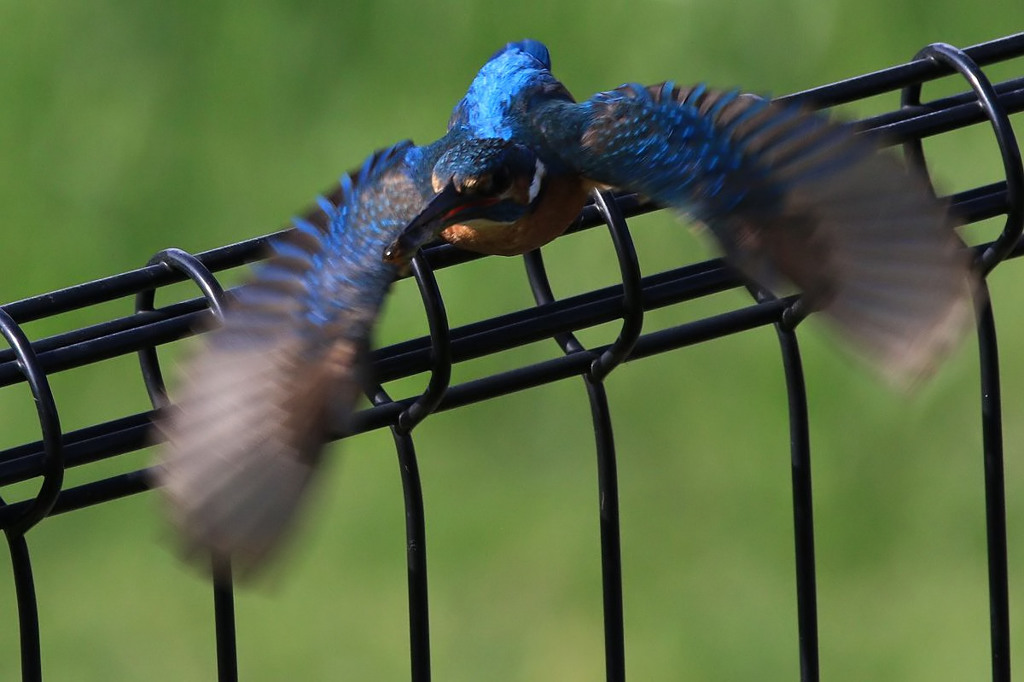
[[441, 176, 591, 256]]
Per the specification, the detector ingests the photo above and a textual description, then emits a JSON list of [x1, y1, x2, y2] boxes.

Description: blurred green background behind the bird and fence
[[0, 0, 1024, 681]]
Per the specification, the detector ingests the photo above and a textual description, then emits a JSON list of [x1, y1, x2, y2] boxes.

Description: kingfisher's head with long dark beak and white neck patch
[[383, 137, 547, 264]]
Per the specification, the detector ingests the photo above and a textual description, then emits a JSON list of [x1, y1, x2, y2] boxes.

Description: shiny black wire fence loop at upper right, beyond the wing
[[900, 43, 1024, 270]]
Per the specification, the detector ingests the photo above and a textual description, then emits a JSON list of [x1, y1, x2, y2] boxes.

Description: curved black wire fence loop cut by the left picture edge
[[0, 308, 65, 535]]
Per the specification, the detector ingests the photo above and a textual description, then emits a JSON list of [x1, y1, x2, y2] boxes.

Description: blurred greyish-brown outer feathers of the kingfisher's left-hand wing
[[157, 332, 357, 574]]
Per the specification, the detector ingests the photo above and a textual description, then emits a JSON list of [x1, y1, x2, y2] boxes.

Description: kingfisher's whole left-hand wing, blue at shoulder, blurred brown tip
[[156, 142, 419, 573]]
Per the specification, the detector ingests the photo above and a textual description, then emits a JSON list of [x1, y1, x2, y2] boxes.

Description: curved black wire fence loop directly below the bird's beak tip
[[396, 251, 452, 433]]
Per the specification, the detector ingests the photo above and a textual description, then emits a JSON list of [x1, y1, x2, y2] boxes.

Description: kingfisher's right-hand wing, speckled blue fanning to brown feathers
[[549, 83, 974, 385]]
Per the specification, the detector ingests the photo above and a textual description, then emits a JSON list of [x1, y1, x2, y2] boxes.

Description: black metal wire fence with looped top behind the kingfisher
[[0, 34, 1024, 681]]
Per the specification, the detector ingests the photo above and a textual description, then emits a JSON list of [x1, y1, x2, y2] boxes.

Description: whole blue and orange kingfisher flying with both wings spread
[[155, 40, 977, 572]]
